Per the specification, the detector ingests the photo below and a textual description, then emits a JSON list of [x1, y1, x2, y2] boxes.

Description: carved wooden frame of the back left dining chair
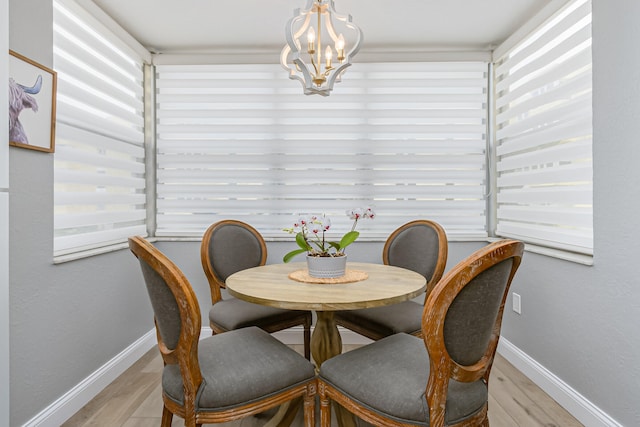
[[200, 219, 313, 360]]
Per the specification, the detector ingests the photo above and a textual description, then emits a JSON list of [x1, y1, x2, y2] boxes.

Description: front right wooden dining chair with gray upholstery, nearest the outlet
[[318, 240, 524, 427]]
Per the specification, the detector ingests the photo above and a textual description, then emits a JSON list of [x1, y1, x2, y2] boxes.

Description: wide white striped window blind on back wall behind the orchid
[[156, 62, 488, 239]]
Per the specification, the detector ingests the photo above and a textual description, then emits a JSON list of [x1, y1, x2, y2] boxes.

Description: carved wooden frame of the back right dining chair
[[336, 219, 449, 341]]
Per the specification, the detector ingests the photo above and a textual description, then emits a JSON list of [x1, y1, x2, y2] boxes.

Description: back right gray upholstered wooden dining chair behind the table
[[334, 219, 448, 340]]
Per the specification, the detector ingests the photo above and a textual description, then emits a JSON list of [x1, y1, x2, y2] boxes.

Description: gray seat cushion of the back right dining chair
[[336, 301, 424, 336]]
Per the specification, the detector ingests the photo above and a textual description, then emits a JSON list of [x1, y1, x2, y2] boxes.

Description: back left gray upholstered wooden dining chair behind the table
[[200, 220, 312, 360]]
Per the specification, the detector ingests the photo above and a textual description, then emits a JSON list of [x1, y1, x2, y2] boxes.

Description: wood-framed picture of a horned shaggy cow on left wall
[[9, 50, 57, 153]]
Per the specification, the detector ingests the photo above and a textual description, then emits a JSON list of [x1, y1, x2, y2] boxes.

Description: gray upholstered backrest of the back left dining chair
[[209, 223, 263, 281]]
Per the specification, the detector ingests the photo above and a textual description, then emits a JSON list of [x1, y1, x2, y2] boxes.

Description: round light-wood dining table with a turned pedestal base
[[226, 262, 426, 426]]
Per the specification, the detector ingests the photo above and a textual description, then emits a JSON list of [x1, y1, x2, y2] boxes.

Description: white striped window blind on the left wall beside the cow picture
[[54, 0, 146, 256]]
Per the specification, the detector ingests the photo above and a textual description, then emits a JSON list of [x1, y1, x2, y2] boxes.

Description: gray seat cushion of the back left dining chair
[[209, 297, 306, 331]]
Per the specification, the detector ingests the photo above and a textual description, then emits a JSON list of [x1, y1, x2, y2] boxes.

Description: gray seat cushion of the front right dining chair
[[319, 334, 488, 426]]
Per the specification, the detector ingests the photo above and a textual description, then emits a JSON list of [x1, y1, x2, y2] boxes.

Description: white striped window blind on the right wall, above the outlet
[[495, 0, 593, 254]]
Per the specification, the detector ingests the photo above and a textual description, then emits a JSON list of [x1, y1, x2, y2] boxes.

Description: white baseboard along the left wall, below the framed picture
[[23, 329, 156, 427]]
